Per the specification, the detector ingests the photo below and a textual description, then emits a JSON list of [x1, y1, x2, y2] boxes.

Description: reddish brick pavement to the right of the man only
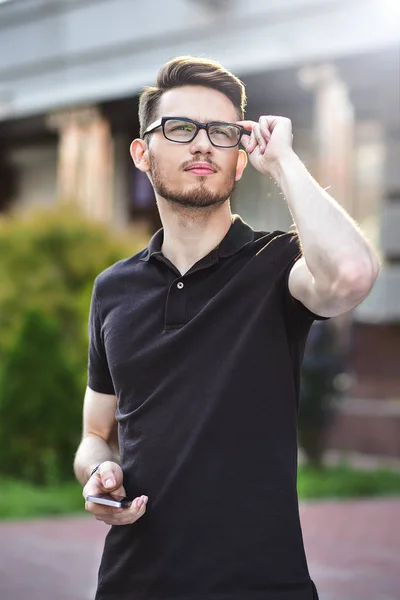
[[301, 498, 400, 600]]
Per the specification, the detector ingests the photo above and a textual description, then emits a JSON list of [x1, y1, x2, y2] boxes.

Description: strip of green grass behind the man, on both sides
[[0, 464, 400, 519]]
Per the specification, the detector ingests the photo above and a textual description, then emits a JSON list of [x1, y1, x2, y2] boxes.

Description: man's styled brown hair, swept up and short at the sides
[[139, 56, 246, 137]]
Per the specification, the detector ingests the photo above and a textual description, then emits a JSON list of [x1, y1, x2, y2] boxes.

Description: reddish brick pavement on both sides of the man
[[0, 498, 400, 600]]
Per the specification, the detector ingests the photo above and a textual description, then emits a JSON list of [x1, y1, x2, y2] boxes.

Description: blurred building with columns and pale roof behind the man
[[0, 0, 400, 456]]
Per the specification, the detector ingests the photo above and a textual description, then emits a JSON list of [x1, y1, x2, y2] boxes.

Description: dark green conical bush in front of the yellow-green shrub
[[0, 308, 81, 484]]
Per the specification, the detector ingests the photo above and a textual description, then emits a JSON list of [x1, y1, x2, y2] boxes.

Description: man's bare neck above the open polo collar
[[158, 198, 232, 275]]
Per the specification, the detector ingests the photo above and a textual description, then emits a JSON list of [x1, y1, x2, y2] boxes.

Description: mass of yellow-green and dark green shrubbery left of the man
[[0, 207, 147, 483]]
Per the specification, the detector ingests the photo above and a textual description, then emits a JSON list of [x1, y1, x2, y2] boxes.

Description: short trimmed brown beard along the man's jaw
[[149, 154, 236, 210]]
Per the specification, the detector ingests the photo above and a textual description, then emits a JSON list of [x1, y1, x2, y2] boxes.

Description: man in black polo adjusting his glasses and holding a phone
[[75, 57, 379, 600]]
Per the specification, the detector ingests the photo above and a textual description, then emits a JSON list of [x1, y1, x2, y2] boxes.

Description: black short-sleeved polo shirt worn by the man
[[88, 216, 324, 600]]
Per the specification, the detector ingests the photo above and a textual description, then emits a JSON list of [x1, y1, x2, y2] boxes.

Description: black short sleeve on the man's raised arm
[[274, 232, 329, 325]]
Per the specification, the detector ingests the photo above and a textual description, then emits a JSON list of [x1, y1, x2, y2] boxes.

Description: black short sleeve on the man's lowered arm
[[88, 284, 115, 395]]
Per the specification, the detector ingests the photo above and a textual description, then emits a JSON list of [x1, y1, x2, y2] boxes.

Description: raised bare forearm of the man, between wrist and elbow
[[271, 151, 379, 285]]
